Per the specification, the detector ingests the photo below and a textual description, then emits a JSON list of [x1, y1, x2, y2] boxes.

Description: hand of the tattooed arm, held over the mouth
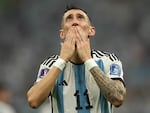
[[75, 27, 91, 62]]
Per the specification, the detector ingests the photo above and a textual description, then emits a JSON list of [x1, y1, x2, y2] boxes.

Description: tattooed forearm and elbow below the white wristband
[[90, 66, 125, 103]]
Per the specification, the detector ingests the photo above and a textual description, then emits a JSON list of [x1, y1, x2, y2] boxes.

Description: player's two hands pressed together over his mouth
[[60, 26, 91, 62]]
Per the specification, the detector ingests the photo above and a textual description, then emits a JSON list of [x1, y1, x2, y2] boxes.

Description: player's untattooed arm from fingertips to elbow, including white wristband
[[27, 26, 75, 108]]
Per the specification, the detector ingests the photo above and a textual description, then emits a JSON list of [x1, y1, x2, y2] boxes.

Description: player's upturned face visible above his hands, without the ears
[[62, 9, 91, 37]]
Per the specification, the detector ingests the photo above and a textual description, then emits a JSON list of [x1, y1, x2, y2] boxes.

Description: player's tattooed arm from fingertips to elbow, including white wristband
[[76, 27, 126, 107]]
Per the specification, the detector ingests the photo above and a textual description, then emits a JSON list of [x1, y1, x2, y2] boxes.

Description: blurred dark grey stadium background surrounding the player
[[0, 0, 150, 113]]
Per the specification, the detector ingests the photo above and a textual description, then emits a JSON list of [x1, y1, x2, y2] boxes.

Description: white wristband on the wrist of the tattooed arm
[[84, 58, 98, 70]]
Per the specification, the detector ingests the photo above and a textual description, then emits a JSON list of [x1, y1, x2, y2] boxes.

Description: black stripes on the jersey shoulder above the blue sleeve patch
[[91, 49, 119, 62]]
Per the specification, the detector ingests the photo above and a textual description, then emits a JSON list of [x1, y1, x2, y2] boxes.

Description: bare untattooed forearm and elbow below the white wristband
[[27, 67, 60, 108]]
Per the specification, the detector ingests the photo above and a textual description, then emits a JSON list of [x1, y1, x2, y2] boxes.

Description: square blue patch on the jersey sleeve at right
[[110, 64, 121, 76]]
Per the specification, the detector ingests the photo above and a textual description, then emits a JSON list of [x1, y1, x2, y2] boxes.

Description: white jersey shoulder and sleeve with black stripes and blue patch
[[92, 50, 123, 80]]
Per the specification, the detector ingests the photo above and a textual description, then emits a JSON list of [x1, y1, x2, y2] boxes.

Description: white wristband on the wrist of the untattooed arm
[[53, 58, 66, 71]]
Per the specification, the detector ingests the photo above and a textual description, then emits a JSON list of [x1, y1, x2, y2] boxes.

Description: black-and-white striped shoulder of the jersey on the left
[[41, 55, 59, 67]]
